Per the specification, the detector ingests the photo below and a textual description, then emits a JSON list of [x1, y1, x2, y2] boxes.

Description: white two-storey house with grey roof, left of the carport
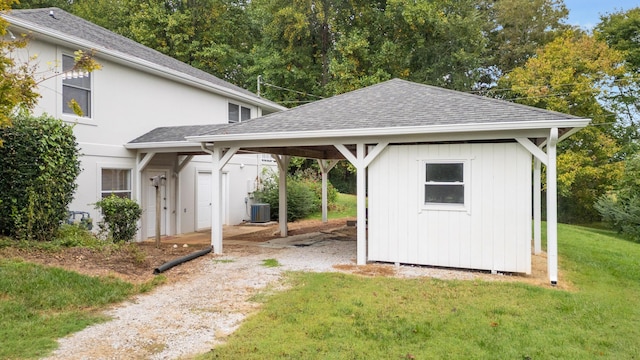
[[2, 8, 285, 238]]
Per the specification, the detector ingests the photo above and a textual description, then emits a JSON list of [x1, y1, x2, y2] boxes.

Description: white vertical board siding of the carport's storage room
[[368, 143, 532, 273]]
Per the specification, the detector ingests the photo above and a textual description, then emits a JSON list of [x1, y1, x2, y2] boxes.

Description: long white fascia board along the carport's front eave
[[186, 119, 590, 143]]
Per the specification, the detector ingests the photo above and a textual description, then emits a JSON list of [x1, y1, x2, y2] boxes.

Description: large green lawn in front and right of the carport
[[202, 225, 640, 359]]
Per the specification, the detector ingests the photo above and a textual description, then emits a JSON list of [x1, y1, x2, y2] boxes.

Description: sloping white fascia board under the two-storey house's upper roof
[[3, 15, 287, 111]]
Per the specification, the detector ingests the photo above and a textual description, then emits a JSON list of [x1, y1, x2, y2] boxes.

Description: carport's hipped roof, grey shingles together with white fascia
[[190, 79, 589, 142]]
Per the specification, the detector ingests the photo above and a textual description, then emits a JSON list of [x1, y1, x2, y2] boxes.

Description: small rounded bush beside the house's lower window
[[95, 194, 142, 242]]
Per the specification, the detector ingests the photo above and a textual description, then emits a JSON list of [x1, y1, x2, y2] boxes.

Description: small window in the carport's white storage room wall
[[424, 162, 465, 205]]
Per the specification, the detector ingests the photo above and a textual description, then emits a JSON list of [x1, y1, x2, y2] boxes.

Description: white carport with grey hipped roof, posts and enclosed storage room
[[181, 79, 589, 284]]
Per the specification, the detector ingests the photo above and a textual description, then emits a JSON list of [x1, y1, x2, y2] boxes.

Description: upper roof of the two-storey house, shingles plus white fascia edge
[[1, 8, 285, 111]]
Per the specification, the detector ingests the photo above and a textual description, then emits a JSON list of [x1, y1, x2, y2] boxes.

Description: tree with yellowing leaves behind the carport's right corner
[[494, 31, 626, 222]]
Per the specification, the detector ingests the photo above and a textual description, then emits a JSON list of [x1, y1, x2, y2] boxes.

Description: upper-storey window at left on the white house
[[62, 55, 91, 117]]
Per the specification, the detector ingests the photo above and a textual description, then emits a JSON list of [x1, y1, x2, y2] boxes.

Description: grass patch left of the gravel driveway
[[0, 259, 137, 359]]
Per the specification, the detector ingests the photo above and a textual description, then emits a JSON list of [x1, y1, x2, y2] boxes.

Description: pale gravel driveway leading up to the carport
[[47, 236, 476, 360]]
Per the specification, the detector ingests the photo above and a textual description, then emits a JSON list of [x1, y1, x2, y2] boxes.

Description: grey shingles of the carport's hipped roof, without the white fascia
[[206, 79, 580, 135]]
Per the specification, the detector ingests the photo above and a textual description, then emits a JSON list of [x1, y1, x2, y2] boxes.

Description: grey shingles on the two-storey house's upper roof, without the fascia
[[4, 8, 270, 106]]
